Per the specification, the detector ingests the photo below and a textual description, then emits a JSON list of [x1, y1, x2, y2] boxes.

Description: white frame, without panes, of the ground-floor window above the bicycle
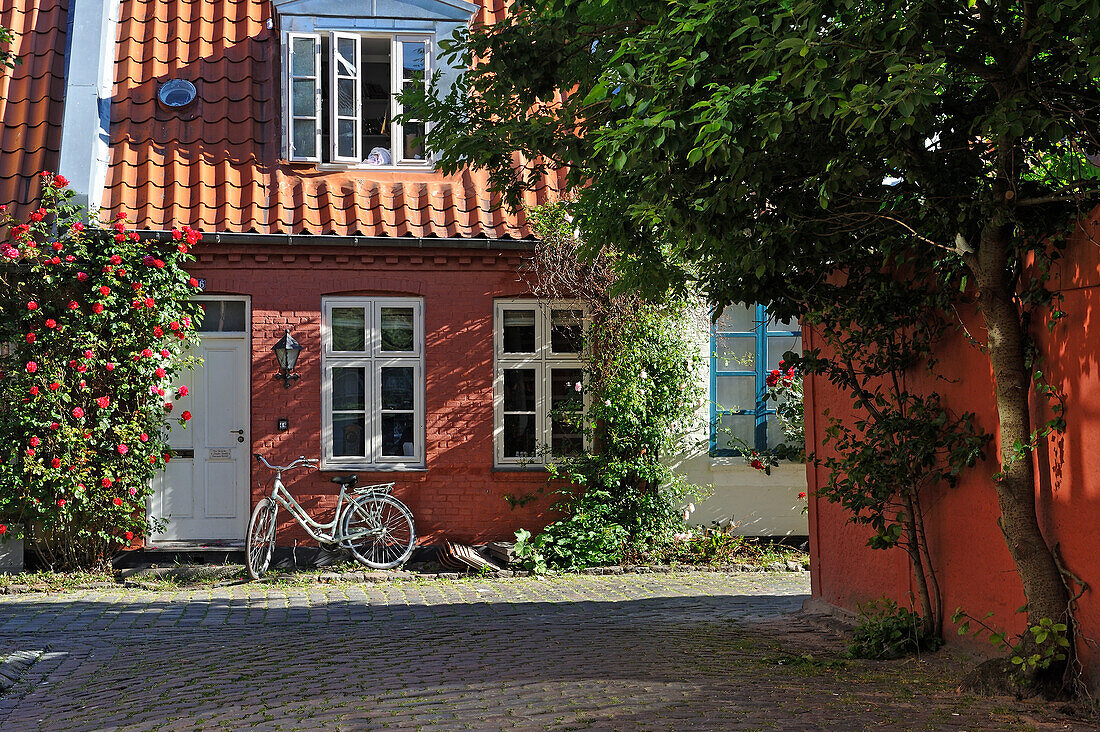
[[321, 297, 427, 471]]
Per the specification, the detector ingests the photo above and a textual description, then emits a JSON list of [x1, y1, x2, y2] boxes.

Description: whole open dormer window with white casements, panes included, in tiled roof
[[284, 31, 433, 166]]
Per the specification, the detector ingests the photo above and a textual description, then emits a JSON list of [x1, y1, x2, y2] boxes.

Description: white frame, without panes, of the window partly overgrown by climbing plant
[[493, 298, 591, 469]]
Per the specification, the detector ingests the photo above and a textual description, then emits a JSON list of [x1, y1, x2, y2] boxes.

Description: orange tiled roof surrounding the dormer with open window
[[99, 0, 564, 239]]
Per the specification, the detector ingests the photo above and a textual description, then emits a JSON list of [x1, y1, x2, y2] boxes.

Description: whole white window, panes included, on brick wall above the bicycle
[[321, 297, 425, 470]]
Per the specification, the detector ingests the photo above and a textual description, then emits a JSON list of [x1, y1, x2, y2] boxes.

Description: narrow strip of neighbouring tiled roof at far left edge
[[0, 0, 68, 214]]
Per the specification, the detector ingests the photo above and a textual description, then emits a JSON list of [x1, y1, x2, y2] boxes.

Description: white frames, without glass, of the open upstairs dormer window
[[283, 29, 436, 170]]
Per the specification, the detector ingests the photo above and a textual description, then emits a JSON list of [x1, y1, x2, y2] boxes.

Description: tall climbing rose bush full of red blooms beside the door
[[0, 173, 200, 569]]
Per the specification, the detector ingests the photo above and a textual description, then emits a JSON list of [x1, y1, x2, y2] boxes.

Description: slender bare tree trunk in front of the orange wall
[[969, 223, 1070, 677]]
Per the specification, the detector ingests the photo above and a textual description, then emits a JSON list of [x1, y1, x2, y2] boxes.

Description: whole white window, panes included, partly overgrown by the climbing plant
[[493, 299, 586, 467]]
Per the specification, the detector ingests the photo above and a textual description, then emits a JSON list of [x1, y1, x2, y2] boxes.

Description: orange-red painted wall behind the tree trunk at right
[[806, 208, 1100, 679]]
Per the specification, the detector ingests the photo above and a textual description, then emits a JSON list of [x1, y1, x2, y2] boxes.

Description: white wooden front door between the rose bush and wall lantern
[[149, 297, 250, 547]]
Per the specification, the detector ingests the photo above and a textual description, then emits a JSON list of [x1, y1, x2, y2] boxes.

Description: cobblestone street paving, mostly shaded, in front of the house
[[0, 572, 1082, 732]]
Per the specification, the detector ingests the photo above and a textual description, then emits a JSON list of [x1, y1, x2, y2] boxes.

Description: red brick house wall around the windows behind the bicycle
[[189, 244, 551, 544]]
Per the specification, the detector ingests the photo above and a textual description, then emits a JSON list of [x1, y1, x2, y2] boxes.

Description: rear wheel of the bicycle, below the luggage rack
[[341, 495, 416, 569]]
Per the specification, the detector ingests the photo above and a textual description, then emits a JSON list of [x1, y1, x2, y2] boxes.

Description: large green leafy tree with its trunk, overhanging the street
[[403, 0, 1100, 691]]
